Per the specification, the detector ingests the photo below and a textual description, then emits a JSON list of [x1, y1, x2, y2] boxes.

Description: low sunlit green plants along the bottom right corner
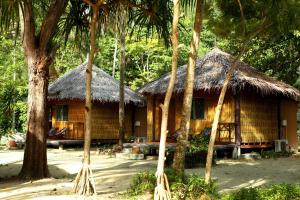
[[222, 183, 300, 200]]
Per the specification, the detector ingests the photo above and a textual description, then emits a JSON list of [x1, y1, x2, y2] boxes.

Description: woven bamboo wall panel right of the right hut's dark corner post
[[241, 96, 278, 143]]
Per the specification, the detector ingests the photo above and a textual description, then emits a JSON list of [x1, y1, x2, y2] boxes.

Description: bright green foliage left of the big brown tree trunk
[[0, 34, 27, 134]]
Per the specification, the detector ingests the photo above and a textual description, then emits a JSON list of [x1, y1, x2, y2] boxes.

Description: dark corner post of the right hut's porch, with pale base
[[232, 89, 241, 159]]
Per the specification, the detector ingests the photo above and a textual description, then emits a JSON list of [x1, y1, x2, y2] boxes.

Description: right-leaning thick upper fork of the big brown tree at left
[[39, 0, 68, 52]]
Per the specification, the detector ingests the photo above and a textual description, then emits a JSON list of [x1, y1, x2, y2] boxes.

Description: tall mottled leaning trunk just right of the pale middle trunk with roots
[[173, 0, 203, 175]]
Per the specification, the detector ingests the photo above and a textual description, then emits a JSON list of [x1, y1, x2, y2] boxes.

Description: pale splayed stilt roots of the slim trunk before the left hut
[[73, 163, 97, 196]]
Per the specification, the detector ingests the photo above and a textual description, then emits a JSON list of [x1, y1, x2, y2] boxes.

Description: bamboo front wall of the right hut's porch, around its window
[[147, 92, 234, 141]]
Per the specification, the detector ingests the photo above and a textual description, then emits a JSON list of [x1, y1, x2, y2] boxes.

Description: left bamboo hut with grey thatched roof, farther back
[[48, 63, 146, 141]]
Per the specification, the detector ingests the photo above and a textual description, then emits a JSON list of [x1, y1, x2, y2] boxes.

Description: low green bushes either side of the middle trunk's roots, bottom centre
[[128, 168, 219, 200]]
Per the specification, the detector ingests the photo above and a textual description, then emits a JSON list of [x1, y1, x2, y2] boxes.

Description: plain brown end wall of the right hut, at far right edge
[[280, 99, 298, 150]]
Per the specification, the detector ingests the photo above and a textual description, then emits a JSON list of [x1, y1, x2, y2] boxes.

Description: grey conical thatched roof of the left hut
[[48, 62, 142, 104]]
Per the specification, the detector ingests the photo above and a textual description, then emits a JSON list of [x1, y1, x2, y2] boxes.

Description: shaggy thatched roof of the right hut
[[138, 48, 300, 101]]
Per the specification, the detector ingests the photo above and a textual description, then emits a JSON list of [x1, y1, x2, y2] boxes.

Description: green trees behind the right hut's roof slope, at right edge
[[217, 32, 300, 89]]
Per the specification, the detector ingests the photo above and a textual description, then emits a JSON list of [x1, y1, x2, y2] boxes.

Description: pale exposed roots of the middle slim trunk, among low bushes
[[154, 173, 171, 200]]
